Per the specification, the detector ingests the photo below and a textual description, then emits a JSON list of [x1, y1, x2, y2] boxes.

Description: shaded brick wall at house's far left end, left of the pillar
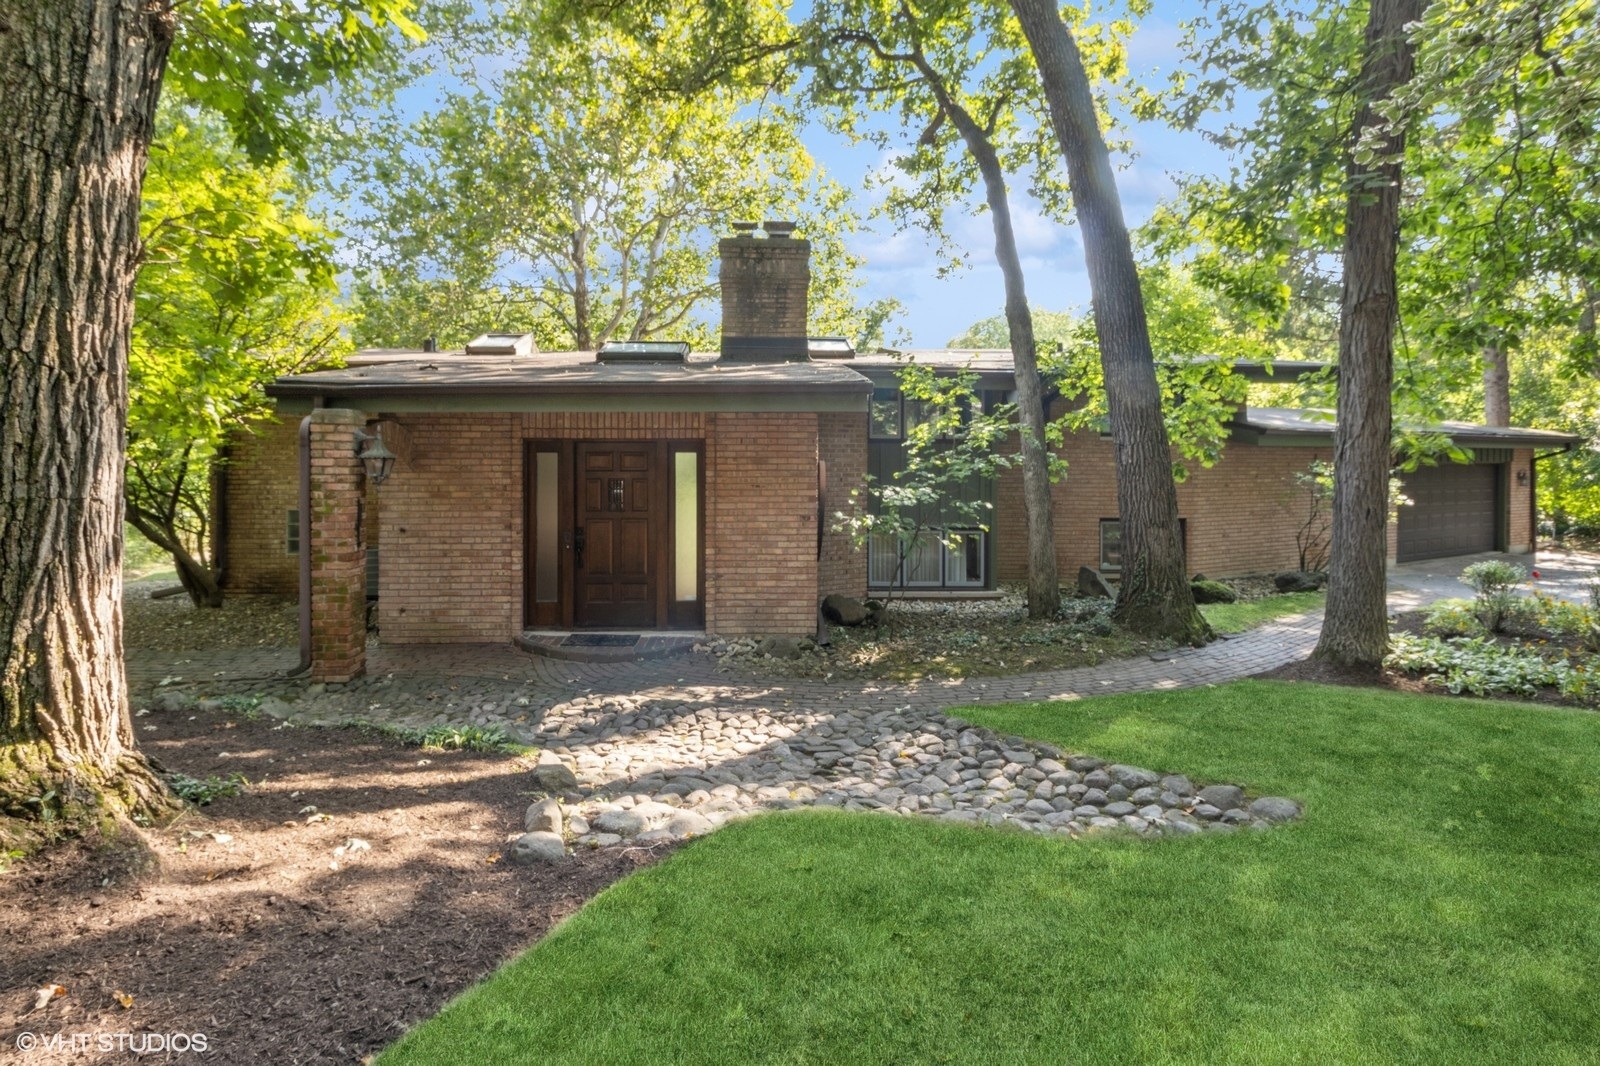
[[224, 415, 301, 595]]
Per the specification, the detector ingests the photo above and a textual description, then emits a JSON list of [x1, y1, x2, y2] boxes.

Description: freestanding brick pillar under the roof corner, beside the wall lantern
[[310, 408, 366, 682]]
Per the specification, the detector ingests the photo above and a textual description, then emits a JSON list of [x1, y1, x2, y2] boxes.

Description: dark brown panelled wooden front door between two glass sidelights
[[573, 442, 661, 627]]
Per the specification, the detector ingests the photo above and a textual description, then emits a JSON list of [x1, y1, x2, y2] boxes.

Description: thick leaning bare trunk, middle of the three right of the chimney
[[1011, 0, 1211, 643]]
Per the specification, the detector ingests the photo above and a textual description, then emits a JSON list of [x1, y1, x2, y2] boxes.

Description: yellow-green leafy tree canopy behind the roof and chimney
[[349, 5, 894, 349]]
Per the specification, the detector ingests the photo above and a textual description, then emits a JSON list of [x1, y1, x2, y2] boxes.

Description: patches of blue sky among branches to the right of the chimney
[[806, 3, 1227, 347]]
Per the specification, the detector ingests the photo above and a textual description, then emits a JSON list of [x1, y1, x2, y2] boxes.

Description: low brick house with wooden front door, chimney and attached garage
[[232, 222, 1574, 680]]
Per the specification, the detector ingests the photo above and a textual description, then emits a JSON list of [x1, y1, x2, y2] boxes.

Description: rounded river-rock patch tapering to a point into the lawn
[[514, 690, 1301, 861]]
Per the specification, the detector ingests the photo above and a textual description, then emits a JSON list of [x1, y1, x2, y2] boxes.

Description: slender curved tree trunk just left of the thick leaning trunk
[[917, 62, 1061, 618]]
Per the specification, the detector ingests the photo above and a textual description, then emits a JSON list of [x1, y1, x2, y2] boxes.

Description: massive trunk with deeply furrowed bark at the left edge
[[0, 0, 173, 821]]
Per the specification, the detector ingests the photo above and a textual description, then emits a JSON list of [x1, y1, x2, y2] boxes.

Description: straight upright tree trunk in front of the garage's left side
[[1312, 0, 1424, 671]]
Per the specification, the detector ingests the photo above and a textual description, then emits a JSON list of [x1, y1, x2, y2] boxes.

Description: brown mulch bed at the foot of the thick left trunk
[[0, 701, 670, 1063]]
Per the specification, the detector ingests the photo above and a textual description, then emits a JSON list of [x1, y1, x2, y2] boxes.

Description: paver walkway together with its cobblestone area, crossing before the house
[[128, 613, 1322, 856]]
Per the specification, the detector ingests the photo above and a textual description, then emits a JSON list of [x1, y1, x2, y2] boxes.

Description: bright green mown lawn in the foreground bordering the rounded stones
[[381, 682, 1600, 1066]]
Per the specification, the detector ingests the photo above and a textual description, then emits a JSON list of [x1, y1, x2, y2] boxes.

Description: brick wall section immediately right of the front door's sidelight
[[706, 413, 819, 635]]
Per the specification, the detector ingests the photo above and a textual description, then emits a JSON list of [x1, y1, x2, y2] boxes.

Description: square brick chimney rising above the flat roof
[[717, 221, 811, 363]]
